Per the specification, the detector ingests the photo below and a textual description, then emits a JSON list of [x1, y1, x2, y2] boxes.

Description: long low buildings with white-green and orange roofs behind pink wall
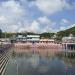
[[13, 35, 55, 43]]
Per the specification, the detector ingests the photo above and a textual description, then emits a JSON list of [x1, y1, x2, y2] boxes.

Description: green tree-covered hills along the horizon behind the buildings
[[1, 26, 75, 40]]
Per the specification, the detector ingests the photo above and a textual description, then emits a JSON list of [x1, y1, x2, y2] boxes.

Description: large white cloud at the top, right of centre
[[35, 0, 72, 15]]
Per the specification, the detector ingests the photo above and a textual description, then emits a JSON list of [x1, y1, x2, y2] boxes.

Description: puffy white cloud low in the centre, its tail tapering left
[[19, 16, 56, 33]]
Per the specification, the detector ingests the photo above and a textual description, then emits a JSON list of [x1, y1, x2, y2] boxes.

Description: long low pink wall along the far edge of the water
[[14, 43, 62, 49]]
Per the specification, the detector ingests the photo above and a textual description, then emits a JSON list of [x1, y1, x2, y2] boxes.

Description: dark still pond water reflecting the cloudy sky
[[5, 49, 75, 75]]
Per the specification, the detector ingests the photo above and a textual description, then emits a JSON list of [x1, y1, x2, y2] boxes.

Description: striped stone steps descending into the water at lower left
[[0, 45, 10, 75]]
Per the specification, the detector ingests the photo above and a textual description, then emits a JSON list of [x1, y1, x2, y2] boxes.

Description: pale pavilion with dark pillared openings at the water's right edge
[[62, 34, 75, 50]]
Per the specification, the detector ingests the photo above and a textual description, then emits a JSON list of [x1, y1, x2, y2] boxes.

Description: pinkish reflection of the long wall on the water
[[14, 48, 57, 57]]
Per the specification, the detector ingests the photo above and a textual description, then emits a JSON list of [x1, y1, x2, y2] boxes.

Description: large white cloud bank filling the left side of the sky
[[0, 0, 28, 32]]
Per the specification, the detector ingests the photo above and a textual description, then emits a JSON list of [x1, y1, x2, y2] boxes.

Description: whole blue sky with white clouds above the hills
[[0, 0, 75, 33]]
